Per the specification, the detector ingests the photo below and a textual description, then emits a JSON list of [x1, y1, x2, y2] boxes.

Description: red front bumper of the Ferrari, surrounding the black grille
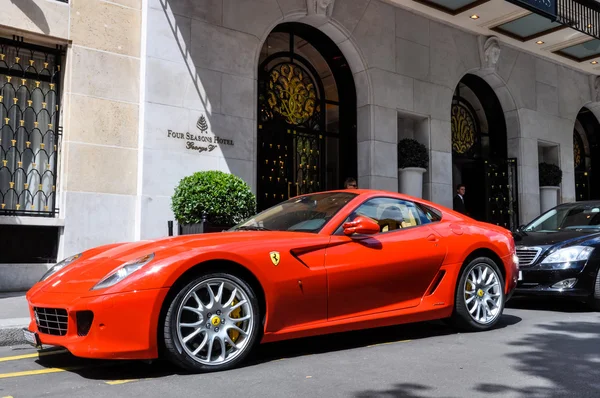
[[23, 288, 168, 359]]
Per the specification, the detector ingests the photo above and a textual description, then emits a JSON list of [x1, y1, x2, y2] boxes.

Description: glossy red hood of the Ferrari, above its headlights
[[42, 231, 315, 293]]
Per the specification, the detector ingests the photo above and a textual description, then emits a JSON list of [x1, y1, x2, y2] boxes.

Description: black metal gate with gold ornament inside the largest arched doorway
[[257, 61, 325, 209]]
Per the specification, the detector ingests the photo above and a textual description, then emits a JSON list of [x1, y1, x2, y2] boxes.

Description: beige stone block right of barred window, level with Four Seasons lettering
[[67, 95, 139, 148]]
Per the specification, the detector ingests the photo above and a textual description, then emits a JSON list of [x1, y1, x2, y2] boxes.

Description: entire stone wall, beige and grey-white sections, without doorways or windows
[[0, 0, 598, 256]]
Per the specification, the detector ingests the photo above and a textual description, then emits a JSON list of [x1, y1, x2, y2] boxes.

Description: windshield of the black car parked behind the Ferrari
[[523, 203, 600, 232]]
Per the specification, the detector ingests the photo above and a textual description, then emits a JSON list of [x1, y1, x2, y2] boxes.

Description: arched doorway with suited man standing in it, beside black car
[[451, 74, 518, 229]]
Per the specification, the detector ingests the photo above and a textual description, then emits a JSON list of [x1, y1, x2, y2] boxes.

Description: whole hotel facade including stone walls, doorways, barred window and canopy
[[0, 0, 600, 291]]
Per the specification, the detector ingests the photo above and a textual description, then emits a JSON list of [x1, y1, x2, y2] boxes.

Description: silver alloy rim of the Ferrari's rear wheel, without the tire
[[464, 263, 503, 325]]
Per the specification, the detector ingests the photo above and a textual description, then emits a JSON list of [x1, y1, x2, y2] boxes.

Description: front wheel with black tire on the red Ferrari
[[164, 273, 261, 373]]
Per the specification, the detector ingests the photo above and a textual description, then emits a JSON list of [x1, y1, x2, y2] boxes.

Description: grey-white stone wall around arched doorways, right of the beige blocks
[[142, 0, 591, 236]]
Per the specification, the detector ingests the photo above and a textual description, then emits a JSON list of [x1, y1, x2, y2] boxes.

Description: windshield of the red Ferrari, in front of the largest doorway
[[230, 192, 357, 233]]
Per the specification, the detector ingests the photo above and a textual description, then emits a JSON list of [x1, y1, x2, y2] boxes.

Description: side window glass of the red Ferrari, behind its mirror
[[336, 198, 441, 234]]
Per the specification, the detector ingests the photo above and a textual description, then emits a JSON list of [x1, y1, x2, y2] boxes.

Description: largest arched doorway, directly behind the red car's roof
[[257, 23, 357, 211]]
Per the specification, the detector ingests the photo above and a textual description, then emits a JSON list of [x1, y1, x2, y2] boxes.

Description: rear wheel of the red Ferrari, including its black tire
[[450, 257, 506, 332]]
